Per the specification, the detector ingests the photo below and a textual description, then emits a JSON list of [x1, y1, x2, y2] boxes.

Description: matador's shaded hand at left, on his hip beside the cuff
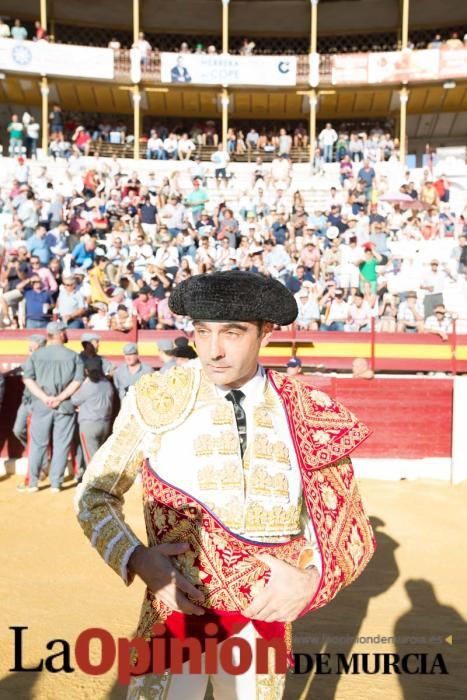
[[128, 542, 204, 615]]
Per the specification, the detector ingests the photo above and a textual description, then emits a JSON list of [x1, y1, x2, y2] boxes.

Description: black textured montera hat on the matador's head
[[169, 270, 298, 326]]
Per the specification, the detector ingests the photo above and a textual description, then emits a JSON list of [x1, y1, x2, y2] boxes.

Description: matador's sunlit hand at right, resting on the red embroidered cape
[[243, 554, 320, 622]]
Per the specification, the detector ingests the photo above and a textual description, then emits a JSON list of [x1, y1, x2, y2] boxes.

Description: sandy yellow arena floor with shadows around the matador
[[0, 477, 467, 700]]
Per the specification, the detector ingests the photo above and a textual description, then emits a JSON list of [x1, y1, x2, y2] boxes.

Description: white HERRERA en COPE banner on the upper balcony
[[161, 53, 297, 87]]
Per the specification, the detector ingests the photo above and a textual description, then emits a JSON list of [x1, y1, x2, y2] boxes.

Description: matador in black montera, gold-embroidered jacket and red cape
[[76, 271, 374, 700]]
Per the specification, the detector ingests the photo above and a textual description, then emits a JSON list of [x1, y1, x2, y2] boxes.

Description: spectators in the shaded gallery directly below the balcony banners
[[7, 105, 399, 167]]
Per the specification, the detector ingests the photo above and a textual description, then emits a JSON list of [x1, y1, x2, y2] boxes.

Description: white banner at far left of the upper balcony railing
[[0, 39, 114, 80]]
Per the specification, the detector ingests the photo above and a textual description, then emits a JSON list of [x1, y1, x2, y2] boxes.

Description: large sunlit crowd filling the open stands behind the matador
[[0, 144, 467, 339]]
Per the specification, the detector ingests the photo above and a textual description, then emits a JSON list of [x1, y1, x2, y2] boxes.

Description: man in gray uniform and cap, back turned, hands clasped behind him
[[24, 321, 84, 493]]
